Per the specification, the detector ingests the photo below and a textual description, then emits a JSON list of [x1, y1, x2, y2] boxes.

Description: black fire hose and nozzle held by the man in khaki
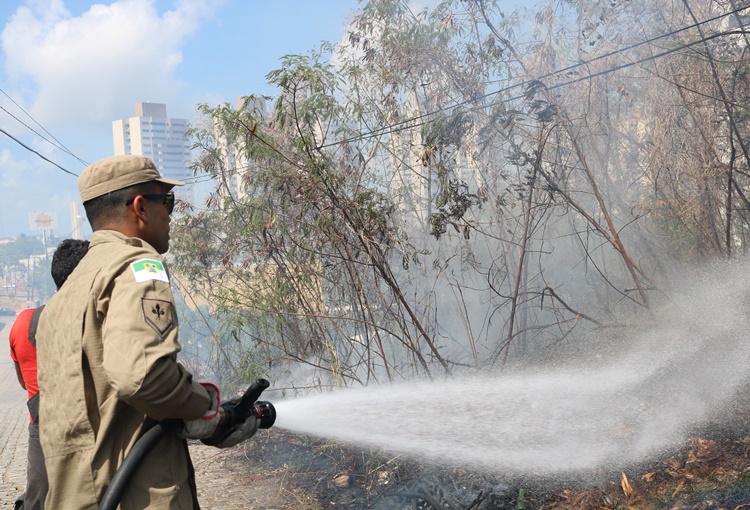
[[99, 379, 276, 510]]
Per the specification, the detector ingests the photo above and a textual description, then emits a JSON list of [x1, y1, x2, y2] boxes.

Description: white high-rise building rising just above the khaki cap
[[112, 103, 193, 202]]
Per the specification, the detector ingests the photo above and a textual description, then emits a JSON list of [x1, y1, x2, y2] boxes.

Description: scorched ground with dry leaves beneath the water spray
[[196, 418, 750, 510]]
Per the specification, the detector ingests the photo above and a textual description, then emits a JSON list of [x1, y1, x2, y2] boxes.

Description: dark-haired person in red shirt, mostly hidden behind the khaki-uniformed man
[[8, 239, 89, 510]]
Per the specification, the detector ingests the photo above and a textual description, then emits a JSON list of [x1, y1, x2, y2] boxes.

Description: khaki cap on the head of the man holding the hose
[[78, 156, 185, 203]]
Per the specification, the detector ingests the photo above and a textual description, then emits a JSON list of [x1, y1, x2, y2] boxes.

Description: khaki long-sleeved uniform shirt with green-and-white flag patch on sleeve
[[37, 230, 210, 510]]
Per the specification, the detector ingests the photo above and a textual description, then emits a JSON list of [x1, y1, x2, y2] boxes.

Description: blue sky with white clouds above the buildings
[[0, 0, 360, 239]]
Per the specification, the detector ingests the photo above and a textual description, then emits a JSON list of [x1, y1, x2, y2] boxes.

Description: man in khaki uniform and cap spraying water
[[37, 156, 259, 510]]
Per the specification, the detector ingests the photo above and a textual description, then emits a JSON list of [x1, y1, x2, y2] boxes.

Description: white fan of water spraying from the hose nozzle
[[275, 264, 750, 481]]
